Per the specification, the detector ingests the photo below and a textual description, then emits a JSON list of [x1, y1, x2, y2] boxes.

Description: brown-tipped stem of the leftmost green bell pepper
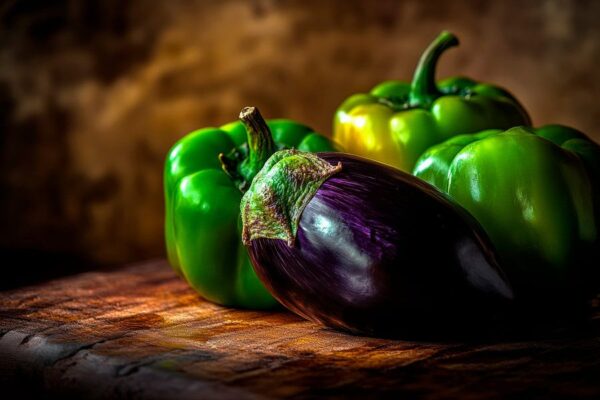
[[240, 107, 275, 184]]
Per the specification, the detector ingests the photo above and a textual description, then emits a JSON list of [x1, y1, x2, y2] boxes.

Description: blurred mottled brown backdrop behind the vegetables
[[0, 0, 600, 286]]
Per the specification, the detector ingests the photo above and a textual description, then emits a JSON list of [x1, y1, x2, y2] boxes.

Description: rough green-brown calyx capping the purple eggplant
[[240, 149, 342, 247]]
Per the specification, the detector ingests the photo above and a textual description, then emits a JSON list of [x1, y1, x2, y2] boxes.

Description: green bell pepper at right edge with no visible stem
[[413, 125, 600, 302]]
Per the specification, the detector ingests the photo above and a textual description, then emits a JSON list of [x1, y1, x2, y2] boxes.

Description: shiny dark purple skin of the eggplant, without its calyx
[[248, 153, 513, 336]]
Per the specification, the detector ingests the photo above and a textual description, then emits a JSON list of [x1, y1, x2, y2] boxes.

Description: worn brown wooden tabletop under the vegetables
[[0, 261, 600, 399]]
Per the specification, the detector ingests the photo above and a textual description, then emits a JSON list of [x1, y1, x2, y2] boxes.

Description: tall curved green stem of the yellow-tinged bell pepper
[[410, 31, 459, 108]]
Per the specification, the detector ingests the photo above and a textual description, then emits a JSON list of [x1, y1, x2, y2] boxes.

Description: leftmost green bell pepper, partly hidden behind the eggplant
[[164, 107, 335, 309]]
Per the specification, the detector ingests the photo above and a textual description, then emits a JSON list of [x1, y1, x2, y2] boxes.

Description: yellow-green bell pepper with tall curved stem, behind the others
[[333, 32, 530, 172]]
